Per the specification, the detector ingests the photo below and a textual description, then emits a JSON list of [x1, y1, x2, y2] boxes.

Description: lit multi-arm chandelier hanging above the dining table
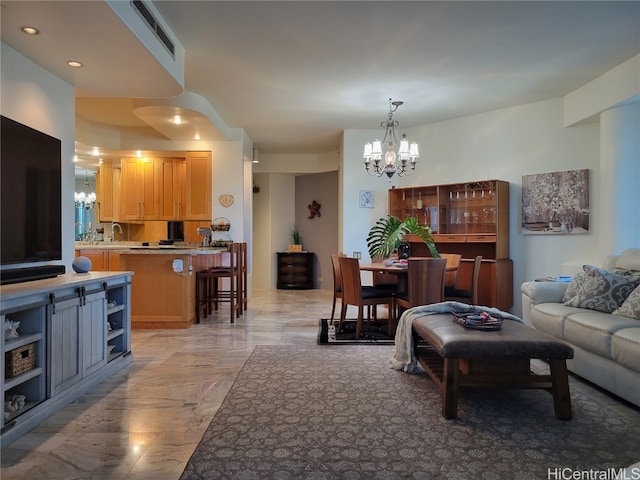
[[362, 99, 420, 181]]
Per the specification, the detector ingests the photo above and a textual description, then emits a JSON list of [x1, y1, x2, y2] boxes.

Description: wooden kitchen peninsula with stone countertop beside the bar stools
[[118, 246, 226, 329]]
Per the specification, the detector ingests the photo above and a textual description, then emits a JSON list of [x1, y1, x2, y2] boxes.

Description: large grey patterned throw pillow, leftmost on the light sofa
[[563, 265, 640, 313]]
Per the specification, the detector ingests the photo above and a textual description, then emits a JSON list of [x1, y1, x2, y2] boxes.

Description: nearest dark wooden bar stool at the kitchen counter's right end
[[196, 242, 246, 323]]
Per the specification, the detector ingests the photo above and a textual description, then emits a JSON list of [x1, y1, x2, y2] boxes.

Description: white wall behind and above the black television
[[0, 43, 75, 271]]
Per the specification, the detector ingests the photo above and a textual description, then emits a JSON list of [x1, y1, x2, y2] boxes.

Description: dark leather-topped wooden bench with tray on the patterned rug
[[412, 313, 573, 420]]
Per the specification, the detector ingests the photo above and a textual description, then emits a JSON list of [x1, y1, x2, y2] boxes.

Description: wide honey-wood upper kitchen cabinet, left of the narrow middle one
[[120, 158, 160, 222]]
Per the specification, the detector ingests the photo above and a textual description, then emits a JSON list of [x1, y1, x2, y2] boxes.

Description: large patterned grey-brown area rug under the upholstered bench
[[181, 345, 640, 480]]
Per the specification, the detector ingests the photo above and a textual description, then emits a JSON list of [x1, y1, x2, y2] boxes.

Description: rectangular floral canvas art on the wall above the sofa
[[522, 169, 589, 234]]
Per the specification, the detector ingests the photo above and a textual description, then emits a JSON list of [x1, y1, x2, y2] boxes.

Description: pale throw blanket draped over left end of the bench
[[391, 302, 523, 373]]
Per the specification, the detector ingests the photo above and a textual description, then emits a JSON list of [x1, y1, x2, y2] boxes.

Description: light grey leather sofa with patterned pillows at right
[[521, 248, 640, 406]]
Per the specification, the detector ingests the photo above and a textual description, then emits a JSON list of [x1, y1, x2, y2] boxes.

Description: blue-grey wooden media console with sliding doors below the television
[[0, 272, 133, 447]]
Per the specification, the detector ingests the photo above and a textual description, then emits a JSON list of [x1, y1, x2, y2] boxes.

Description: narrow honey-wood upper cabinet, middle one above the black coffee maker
[[158, 158, 187, 220]]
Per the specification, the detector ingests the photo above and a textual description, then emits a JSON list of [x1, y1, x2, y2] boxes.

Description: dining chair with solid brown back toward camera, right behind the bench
[[395, 258, 447, 318]]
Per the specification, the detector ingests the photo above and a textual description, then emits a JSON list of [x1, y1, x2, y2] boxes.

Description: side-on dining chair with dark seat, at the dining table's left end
[[338, 256, 395, 340]]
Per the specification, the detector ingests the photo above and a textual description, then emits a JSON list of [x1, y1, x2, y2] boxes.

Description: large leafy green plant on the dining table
[[367, 215, 440, 259]]
